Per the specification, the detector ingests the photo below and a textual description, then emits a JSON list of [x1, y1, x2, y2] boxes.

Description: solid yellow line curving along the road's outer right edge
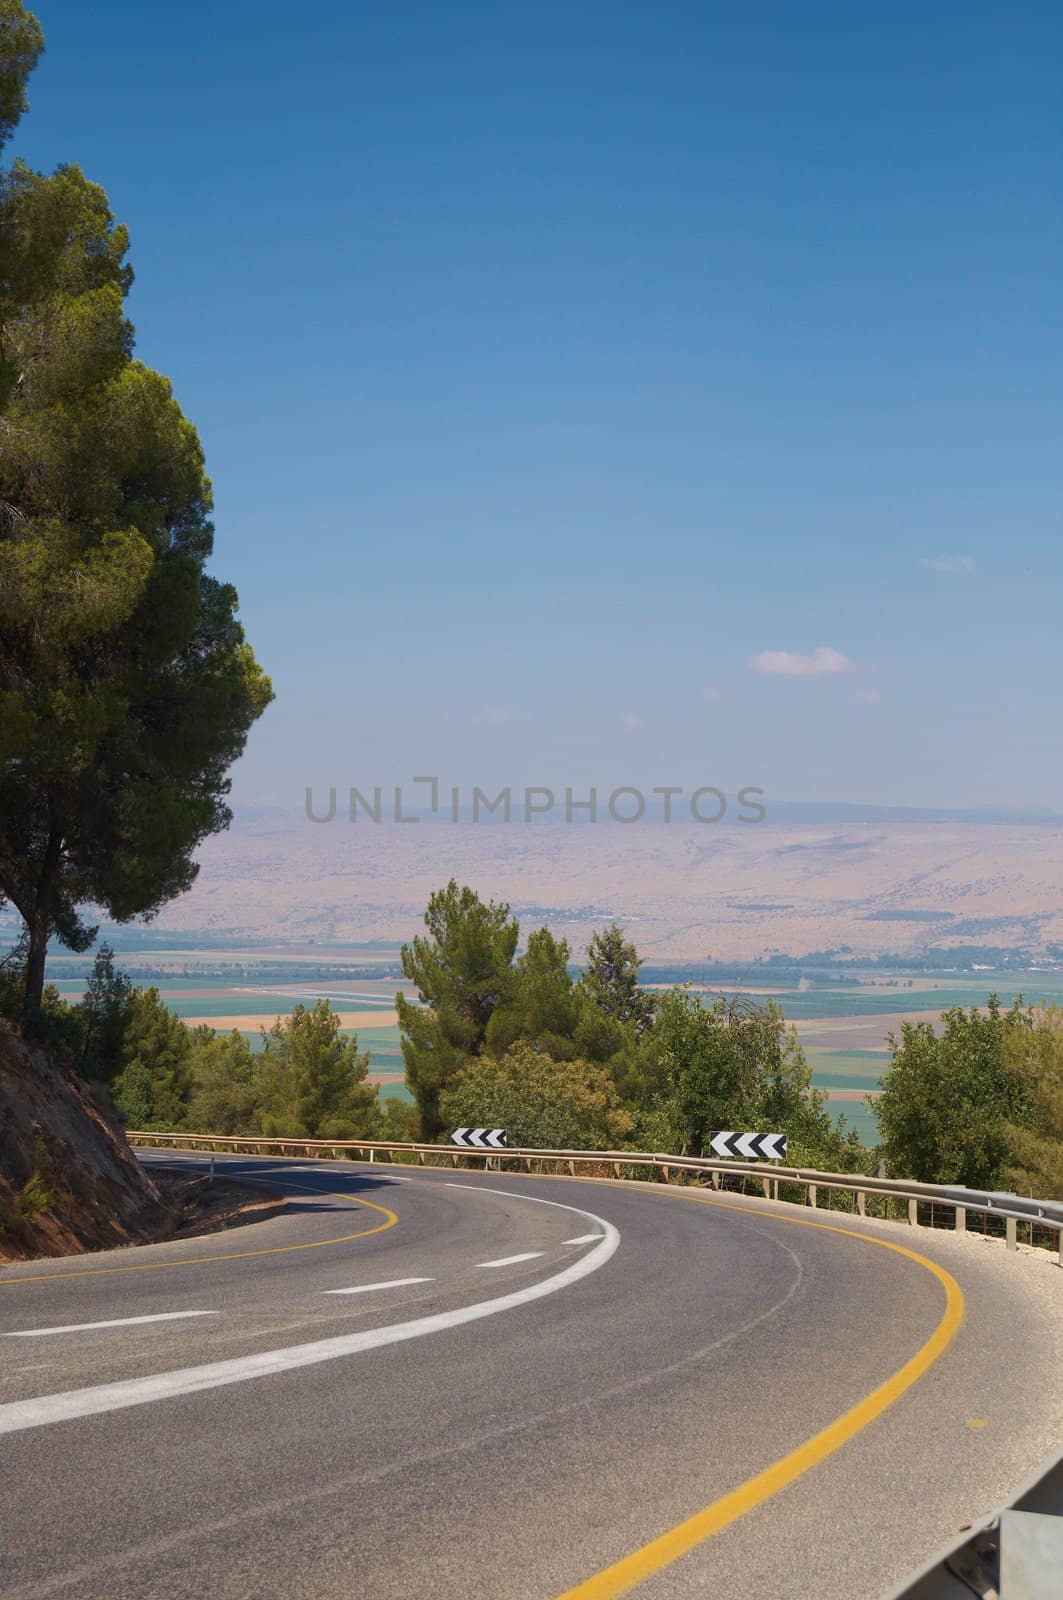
[[547, 1190, 964, 1600]]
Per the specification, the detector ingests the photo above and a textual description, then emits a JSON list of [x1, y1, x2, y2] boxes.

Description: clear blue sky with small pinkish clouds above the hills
[[16, 0, 1063, 808]]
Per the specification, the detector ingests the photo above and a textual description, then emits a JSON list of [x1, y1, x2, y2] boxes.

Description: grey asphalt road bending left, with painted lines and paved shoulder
[[0, 1157, 1058, 1600]]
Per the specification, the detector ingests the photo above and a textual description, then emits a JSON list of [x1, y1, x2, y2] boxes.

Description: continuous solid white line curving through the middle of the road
[[0, 1184, 620, 1434]]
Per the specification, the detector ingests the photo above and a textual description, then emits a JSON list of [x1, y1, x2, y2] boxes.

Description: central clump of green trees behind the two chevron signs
[[399, 882, 864, 1168]]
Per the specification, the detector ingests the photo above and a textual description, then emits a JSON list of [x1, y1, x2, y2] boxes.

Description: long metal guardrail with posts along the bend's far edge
[[126, 1130, 1063, 1266]]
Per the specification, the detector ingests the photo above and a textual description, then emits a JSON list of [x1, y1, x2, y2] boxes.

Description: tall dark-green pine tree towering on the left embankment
[[0, 0, 272, 1026]]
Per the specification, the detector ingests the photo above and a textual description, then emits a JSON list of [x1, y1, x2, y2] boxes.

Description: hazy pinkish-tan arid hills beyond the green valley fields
[[136, 811, 1063, 962]]
